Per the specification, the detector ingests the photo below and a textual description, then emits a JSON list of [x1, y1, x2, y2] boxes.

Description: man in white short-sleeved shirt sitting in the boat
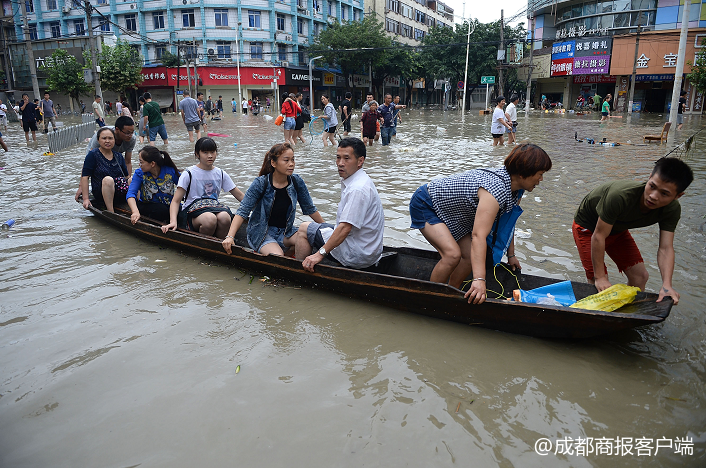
[[295, 138, 385, 272]]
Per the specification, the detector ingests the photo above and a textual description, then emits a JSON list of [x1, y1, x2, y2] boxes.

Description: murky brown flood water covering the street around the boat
[[0, 110, 706, 468]]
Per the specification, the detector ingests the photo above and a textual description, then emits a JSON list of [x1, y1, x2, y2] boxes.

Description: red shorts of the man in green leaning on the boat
[[571, 221, 644, 280]]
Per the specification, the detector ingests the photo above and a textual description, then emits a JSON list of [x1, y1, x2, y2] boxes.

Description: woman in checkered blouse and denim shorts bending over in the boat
[[409, 143, 552, 304]]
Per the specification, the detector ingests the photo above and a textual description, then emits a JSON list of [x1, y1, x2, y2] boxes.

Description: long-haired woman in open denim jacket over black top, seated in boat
[[223, 143, 324, 255]]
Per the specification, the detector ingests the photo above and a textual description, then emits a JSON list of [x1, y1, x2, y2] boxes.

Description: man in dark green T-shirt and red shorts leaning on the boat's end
[[572, 158, 694, 304]]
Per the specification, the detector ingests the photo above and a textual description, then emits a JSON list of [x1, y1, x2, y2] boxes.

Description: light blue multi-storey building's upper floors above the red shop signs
[[11, 0, 363, 66]]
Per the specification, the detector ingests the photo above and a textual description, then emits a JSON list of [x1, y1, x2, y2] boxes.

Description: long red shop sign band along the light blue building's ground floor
[[140, 66, 287, 87]]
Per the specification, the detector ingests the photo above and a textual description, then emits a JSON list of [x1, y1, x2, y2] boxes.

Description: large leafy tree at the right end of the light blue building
[[309, 16, 392, 88]]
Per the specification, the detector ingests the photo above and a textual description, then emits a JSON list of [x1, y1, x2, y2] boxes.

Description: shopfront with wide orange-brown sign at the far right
[[610, 28, 706, 114]]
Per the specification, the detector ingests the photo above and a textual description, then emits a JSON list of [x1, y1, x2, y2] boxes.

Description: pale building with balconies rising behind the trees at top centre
[[365, 0, 454, 45]]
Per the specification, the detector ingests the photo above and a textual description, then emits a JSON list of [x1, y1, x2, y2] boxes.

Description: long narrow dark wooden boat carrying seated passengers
[[90, 207, 672, 338]]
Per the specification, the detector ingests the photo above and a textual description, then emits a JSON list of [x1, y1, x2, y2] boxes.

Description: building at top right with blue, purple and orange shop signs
[[528, 0, 706, 113]]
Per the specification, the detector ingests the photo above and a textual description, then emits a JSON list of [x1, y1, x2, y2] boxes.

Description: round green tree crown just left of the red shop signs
[[98, 41, 143, 94]]
